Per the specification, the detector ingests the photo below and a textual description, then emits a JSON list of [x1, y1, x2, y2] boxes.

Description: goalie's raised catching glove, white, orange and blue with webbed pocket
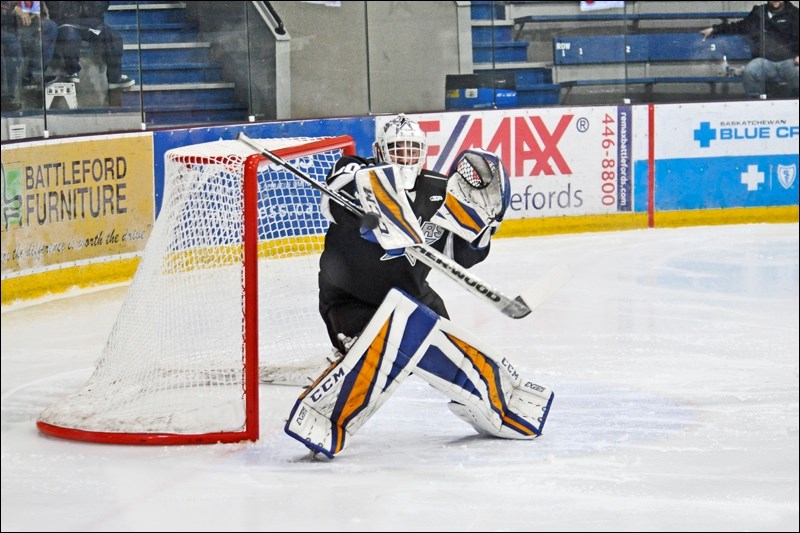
[[431, 148, 511, 248]]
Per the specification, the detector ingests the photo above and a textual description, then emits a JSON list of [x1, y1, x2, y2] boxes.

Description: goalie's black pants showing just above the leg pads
[[319, 279, 450, 353]]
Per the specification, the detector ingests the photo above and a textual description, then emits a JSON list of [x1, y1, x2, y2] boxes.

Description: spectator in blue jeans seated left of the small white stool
[[17, 2, 58, 89]]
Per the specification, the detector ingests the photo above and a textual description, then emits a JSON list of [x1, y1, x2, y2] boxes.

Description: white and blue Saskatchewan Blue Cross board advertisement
[[636, 100, 800, 211]]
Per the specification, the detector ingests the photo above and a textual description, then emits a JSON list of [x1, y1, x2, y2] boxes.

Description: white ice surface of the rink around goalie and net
[[2, 224, 800, 531]]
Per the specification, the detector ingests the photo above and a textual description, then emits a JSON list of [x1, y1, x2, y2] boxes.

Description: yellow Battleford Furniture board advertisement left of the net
[[0, 134, 153, 279]]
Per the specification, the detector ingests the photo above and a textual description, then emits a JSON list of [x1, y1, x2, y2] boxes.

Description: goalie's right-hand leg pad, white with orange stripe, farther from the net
[[414, 318, 553, 439]]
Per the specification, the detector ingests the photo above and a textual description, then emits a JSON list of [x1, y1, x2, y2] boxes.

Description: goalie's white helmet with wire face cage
[[372, 114, 428, 189]]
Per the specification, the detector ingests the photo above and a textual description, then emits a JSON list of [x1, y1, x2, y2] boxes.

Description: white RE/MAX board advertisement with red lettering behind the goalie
[[396, 106, 633, 219]]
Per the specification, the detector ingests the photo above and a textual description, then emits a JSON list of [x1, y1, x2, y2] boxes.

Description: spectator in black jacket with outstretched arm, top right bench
[[700, 1, 800, 98]]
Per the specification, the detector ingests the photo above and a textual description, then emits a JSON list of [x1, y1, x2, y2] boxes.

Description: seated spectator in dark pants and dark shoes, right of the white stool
[[48, 1, 136, 89]]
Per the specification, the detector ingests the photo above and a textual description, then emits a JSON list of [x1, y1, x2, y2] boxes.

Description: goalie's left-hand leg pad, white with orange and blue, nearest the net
[[285, 289, 439, 458]]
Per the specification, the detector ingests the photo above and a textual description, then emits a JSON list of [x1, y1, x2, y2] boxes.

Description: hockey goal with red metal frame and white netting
[[37, 136, 355, 444]]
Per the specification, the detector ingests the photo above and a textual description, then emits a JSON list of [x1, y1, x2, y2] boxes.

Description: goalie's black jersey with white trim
[[319, 156, 489, 307]]
